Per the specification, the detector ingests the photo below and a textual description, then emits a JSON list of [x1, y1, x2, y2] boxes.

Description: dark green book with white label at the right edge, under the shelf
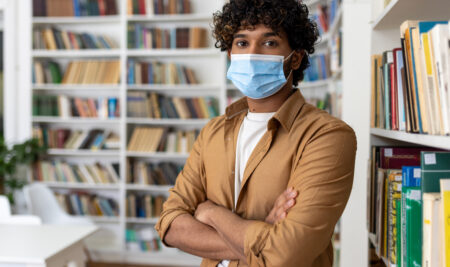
[[420, 151, 450, 193]]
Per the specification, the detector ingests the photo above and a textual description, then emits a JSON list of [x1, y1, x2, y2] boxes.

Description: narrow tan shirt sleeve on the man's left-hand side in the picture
[[155, 123, 207, 245]]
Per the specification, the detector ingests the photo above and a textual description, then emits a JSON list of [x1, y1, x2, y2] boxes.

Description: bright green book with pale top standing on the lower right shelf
[[402, 187, 422, 267]]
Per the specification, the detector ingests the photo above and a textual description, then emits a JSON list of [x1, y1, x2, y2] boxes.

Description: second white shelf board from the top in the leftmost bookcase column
[[31, 49, 120, 58]]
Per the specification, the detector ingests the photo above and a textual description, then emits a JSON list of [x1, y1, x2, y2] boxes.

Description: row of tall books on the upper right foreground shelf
[[371, 21, 450, 135]]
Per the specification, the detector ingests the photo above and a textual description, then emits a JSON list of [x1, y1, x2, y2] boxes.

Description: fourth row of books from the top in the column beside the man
[[127, 92, 219, 119]]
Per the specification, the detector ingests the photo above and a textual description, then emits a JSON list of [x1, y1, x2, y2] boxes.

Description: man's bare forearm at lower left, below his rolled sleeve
[[164, 214, 239, 260]]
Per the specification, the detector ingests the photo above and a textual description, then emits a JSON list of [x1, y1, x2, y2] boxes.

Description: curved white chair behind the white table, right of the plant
[[23, 183, 94, 225]]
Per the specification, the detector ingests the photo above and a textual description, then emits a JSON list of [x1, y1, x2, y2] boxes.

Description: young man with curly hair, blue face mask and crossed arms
[[156, 0, 356, 267]]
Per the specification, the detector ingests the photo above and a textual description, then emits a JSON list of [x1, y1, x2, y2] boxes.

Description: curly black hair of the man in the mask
[[213, 0, 319, 86]]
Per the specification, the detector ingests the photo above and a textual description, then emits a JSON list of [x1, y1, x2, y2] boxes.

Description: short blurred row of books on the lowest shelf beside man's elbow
[[125, 226, 162, 252]]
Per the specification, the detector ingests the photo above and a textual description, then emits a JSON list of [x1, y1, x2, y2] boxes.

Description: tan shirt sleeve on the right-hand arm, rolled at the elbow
[[244, 124, 356, 267]]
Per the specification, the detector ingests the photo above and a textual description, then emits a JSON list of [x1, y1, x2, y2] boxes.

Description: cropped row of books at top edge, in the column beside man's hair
[[127, 0, 191, 15]]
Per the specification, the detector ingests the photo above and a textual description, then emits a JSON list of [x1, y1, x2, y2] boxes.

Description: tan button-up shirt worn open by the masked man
[[156, 90, 356, 267]]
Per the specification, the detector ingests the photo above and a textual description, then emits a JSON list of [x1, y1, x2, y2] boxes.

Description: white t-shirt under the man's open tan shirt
[[217, 112, 275, 267]]
